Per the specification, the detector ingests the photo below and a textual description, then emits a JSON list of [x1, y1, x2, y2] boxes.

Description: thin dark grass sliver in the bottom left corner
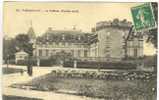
[[2, 95, 42, 100]]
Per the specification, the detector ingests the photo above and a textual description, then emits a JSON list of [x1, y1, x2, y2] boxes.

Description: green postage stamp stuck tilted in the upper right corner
[[131, 3, 156, 31]]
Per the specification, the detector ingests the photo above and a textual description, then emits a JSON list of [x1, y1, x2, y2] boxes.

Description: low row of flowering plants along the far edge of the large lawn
[[50, 69, 157, 80]]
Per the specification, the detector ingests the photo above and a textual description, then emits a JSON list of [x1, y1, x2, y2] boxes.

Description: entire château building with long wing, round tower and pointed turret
[[28, 19, 143, 61]]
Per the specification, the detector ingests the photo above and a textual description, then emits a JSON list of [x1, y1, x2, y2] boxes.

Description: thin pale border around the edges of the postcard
[[0, 0, 159, 100]]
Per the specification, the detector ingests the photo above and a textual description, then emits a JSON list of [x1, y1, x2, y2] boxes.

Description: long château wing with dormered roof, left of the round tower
[[34, 29, 94, 58]]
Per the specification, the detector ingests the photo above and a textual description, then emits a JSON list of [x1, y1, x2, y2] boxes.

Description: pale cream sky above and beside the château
[[3, 2, 155, 55]]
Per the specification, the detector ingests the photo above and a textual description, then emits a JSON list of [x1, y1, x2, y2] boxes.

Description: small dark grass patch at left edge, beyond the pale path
[[2, 67, 23, 74]]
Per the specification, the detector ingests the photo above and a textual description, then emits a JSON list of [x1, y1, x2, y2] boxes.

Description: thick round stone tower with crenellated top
[[93, 20, 131, 59]]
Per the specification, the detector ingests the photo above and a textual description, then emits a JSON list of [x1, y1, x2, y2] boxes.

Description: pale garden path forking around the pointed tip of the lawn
[[2, 65, 102, 100]]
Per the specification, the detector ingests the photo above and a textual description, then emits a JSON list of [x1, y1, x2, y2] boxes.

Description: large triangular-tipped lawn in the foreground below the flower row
[[11, 69, 156, 100]]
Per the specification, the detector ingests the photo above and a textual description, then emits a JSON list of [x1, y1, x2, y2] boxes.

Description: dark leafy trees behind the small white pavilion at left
[[3, 34, 33, 60]]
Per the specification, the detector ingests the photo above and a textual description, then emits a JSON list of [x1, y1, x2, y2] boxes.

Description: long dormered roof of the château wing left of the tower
[[36, 28, 98, 43]]
